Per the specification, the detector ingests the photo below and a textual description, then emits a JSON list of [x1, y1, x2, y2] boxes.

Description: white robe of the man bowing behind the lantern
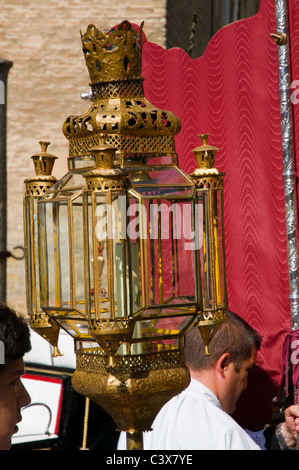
[[118, 379, 261, 450]]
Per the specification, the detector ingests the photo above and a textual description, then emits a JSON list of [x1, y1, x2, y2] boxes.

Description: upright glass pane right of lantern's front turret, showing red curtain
[[128, 196, 201, 305]]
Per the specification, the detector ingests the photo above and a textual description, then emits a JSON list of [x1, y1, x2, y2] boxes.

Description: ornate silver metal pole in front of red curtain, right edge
[[271, 0, 299, 330]]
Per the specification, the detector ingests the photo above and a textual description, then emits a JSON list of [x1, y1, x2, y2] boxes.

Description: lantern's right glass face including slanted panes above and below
[[127, 167, 201, 342]]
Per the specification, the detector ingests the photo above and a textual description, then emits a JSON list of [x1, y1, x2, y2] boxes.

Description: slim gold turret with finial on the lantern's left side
[[24, 141, 60, 356]]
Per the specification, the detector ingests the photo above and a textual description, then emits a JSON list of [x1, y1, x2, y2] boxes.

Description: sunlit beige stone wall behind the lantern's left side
[[0, 0, 166, 312]]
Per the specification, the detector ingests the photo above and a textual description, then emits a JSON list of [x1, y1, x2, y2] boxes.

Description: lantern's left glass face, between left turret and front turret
[[38, 173, 88, 337]]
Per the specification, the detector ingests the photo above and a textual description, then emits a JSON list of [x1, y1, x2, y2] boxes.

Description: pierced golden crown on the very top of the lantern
[[81, 20, 143, 85]]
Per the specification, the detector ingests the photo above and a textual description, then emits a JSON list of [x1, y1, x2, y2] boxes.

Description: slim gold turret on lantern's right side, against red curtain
[[191, 134, 227, 354]]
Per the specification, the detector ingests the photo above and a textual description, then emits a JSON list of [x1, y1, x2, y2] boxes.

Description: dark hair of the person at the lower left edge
[[0, 302, 31, 371]]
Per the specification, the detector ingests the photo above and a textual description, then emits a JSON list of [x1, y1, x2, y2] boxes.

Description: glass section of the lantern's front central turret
[[84, 191, 139, 319]]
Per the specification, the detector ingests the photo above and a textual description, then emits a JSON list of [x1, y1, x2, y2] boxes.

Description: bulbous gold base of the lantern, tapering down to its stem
[[72, 351, 190, 435]]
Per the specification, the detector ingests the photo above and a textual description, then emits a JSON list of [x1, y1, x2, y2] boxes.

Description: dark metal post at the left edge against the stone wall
[[0, 59, 13, 302]]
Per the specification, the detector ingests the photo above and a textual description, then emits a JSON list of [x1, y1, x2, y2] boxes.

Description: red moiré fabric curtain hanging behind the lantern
[[143, 0, 299, 430]]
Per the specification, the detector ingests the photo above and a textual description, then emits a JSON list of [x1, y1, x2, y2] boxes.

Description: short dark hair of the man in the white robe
[[185, 311, 262, 371]]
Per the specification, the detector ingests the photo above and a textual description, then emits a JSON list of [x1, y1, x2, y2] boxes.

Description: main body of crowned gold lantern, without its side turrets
[[24, 21, 224, 449]]
